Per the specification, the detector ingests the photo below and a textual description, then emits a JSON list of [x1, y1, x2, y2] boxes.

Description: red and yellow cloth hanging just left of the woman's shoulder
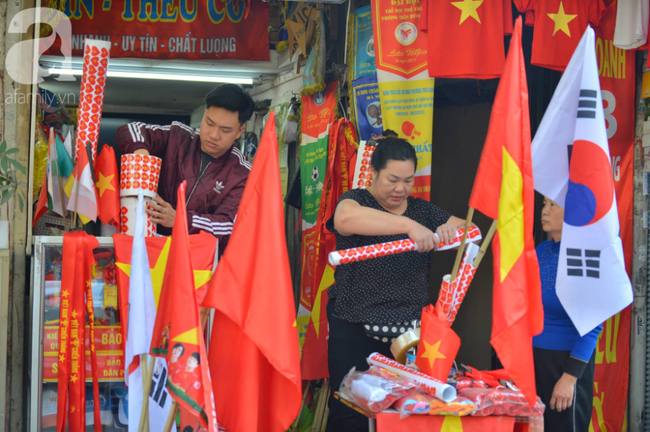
[[301, 118, 357, 380]]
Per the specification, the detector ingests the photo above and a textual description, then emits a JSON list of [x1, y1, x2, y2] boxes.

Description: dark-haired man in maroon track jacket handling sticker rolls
[[115, 84, 255, 253]]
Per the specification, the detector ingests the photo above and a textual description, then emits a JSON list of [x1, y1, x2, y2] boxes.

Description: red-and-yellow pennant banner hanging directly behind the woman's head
[[371, 0, 434, 201]]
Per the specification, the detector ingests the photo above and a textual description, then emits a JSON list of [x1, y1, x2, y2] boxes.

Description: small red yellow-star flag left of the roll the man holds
[[95, 144, 120, 231]]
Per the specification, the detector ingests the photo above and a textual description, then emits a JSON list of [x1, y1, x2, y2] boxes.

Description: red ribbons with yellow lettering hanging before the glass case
[[56, 231, 102, 432]]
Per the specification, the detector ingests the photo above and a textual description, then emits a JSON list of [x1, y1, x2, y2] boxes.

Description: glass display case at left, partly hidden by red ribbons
[[29, 237, 128, 432]]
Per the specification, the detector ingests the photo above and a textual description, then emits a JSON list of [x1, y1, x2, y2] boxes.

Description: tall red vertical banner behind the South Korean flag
[[589, 0, 636, 432]]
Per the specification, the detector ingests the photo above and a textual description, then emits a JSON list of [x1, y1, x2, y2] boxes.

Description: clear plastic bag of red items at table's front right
[[458, 387, 545, 417]]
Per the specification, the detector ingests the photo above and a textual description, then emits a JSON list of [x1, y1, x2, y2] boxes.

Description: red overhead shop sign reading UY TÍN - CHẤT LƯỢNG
[[42, 0, 269, 61]]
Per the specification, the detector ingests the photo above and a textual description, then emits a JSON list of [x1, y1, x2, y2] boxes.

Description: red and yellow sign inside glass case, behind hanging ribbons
[[43, 326, 124, 382]]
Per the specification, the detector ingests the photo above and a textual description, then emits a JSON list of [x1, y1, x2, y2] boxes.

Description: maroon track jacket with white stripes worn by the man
[[115, 122, 251, 255]]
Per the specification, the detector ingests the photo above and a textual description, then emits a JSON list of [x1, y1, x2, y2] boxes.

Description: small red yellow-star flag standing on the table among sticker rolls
[[415, 305, 460, 382]]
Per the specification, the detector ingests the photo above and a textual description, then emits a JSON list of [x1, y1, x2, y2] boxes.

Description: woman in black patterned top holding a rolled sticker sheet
[[327, 137, 465, 432]]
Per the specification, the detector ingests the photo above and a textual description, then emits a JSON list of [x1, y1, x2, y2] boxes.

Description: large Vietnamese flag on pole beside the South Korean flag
[[469, 17, 544, 406]]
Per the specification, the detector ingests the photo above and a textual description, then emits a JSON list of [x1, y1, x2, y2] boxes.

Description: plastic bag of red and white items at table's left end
[[340, 366, 418, 413]]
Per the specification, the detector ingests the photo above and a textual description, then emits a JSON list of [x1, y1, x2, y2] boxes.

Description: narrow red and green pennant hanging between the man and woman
[[297, 82, 338, 362]]
